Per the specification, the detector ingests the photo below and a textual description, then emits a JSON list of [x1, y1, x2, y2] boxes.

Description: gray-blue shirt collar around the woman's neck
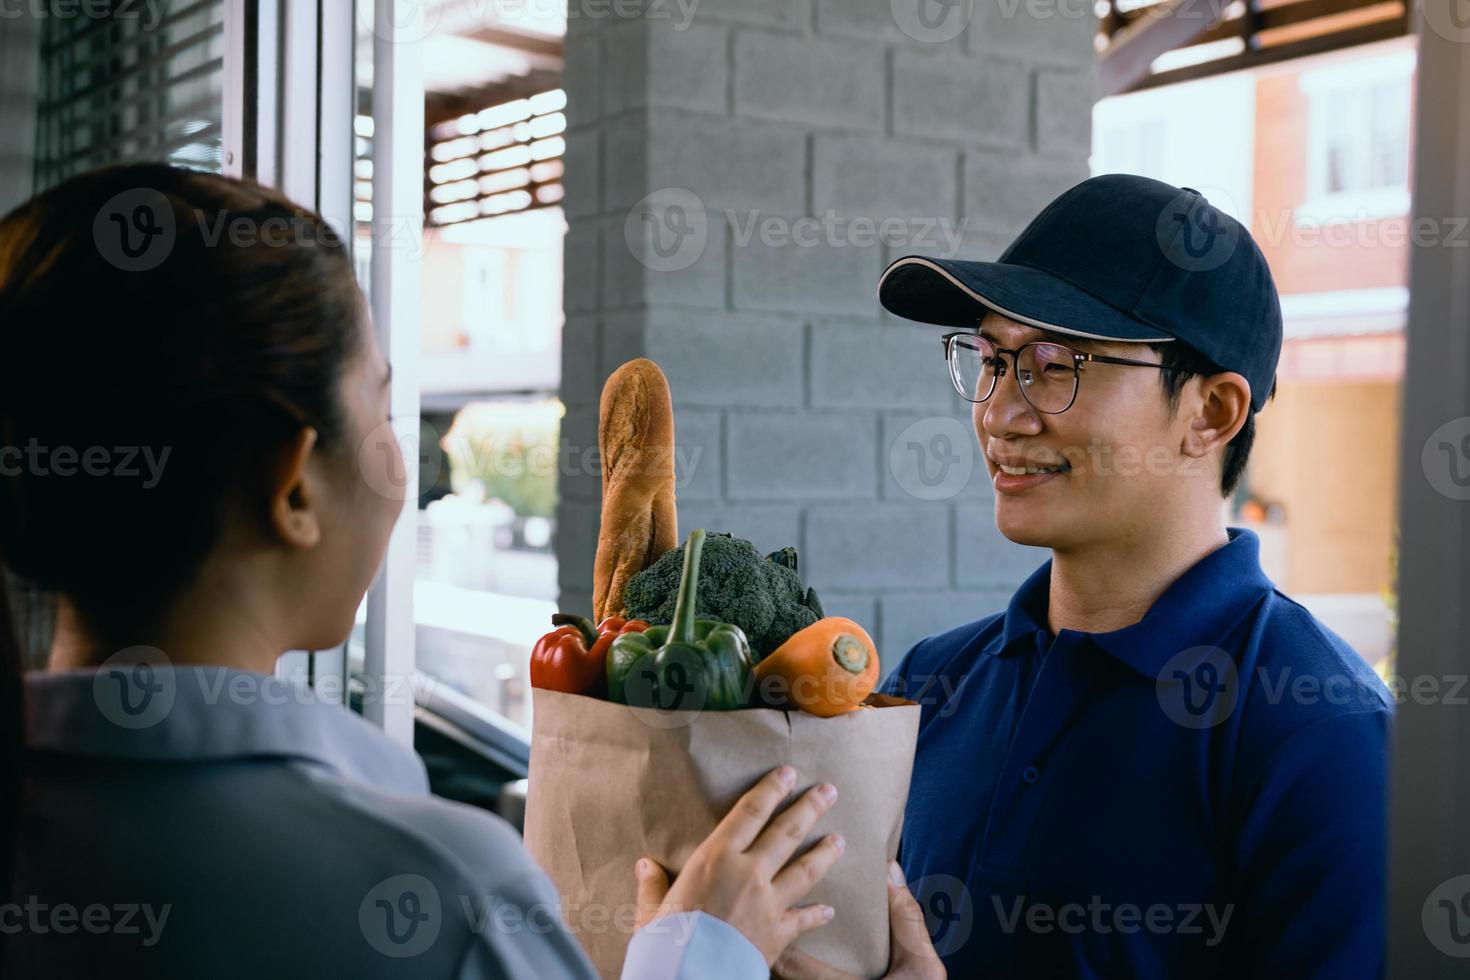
[[25, 664, 428, 795]]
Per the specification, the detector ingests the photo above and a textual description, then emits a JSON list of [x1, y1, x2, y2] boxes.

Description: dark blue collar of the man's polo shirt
[[995, 527, 1276, 679]]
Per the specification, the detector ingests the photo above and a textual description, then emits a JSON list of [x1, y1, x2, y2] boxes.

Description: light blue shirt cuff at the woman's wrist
[[622, 912, 770, 980]]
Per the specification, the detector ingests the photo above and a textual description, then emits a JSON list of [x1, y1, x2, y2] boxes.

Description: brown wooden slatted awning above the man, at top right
[[1098, 0, 1408, 96]]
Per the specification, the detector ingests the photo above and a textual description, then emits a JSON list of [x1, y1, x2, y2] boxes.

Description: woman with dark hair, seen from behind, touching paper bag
[[0, 165, 928, 979]]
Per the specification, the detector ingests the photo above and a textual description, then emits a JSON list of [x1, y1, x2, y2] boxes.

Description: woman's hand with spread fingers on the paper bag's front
[[638, 765, 847, 964]]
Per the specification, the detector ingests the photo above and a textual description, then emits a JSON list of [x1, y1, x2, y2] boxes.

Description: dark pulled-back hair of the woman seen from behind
[[0, 165, 363, 922]]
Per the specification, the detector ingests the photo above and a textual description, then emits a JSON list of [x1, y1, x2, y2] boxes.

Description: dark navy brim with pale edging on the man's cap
[[878, 256, 1175, 344]]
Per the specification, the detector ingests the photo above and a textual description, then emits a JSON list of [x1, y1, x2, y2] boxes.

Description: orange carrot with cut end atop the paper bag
[[756, 616, 878, 718]]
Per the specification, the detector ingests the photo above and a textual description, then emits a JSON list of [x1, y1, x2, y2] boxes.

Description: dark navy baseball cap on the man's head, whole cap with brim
[[878, 173, 1282, 411]]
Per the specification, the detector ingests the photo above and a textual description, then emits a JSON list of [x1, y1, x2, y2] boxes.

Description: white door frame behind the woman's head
[[223, 0, 423, 734]]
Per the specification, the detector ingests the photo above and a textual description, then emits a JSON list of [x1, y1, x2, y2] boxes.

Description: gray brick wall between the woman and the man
[[557, 0, 1094, 667]]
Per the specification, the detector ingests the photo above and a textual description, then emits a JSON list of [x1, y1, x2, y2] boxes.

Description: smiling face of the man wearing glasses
[[973, 313, 1208, 550]]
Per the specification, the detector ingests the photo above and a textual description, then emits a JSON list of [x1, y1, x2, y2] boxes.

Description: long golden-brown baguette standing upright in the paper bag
[[592, 357, 679, 623]]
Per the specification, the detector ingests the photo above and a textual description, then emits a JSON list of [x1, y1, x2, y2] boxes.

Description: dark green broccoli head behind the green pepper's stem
[[623, 532, 822, 661]]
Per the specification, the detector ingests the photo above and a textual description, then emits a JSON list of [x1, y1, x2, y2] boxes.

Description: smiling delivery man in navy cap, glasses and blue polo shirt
[[858, 175, 1392, 980]]
